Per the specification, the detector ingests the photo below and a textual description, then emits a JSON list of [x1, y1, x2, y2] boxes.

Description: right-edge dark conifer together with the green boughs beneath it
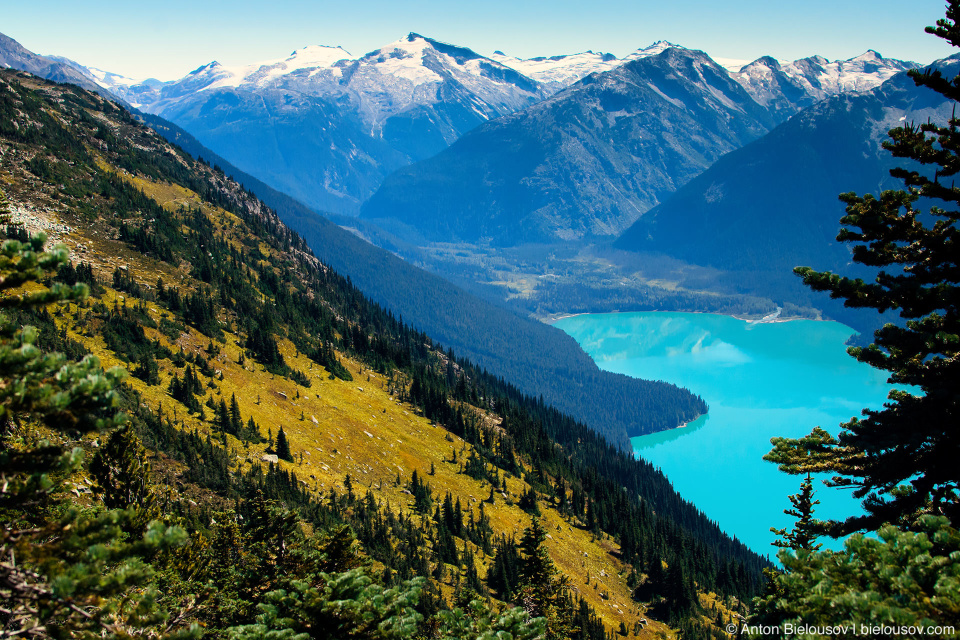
[[750, 0, 960, 636]]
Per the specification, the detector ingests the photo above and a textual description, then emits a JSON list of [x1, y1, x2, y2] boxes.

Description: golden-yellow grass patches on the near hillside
[[3, 154, 748, 638]]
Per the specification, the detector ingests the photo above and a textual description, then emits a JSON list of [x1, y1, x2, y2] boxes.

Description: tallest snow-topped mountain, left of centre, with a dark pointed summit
[[108, 33, 547, 213]]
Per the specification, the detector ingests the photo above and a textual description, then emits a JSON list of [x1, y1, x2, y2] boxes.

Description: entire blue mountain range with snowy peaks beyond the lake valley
[[0, 28, 928, 328]]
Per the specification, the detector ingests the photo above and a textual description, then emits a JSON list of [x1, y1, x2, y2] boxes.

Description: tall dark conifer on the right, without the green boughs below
[[767, 0, 960, 535]]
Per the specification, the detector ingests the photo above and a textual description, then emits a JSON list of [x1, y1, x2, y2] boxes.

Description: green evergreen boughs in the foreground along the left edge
[[0, 191, 189, 638]]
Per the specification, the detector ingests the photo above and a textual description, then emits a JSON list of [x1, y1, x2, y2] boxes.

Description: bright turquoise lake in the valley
[[554, 312, 890, 557]]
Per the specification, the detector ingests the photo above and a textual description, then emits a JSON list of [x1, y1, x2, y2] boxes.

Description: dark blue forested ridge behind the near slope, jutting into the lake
[[134, 114, 706, 447]]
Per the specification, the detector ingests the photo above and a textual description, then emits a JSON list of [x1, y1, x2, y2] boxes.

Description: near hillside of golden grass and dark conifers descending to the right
[[0, 71, 764, 638]]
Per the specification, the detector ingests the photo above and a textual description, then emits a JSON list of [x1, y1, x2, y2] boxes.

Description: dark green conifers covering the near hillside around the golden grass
[[0, 72, 762, 640]]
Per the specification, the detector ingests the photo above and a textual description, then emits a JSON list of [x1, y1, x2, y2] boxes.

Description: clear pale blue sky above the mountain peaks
[[0, 0, 953, 80]]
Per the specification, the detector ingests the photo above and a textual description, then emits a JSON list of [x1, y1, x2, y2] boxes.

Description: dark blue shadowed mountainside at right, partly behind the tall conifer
[[615, 57, 960, 282]]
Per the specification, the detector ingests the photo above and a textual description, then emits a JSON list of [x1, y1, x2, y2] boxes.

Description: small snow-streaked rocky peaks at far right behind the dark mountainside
[[731, 50, 919, 120]]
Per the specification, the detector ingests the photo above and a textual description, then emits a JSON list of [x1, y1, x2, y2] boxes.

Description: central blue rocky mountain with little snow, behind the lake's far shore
[[361, 45, 774, 246]]
